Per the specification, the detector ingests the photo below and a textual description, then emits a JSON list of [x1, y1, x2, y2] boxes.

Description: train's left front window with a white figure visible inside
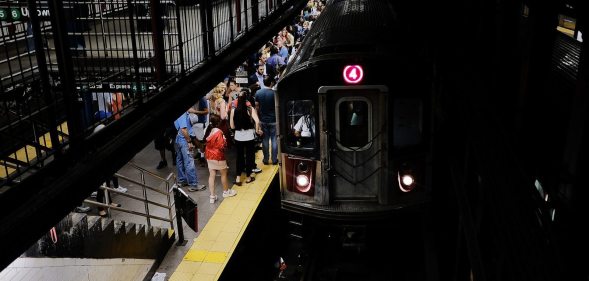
[[286, 100, 316, 149]]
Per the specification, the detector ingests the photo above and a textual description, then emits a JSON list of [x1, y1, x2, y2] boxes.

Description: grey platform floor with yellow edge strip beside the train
[[0, 137, 278, 281]]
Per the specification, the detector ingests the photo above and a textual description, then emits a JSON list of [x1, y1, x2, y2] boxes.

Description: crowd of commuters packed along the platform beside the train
[[158, 0, 324, 203]]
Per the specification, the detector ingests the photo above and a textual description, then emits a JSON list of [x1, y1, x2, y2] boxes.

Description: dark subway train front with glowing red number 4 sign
[[277, 0, 433, 220]]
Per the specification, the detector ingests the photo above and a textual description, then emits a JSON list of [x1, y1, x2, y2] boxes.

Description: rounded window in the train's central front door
[[336, 97, 372, 150]]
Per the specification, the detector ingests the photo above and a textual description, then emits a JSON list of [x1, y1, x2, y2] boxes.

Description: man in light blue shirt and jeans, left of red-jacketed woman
[[174, 109, 206, 191]]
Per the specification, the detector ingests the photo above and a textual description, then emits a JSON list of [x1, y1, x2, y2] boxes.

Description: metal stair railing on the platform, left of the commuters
[[84, 163, 181, 229]]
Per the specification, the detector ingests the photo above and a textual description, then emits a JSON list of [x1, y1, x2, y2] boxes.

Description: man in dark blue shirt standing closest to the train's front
[[256, 76, 278, 165]]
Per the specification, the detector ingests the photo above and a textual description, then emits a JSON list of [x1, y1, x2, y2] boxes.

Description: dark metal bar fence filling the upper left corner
[[0, 0, 294, 188]]
